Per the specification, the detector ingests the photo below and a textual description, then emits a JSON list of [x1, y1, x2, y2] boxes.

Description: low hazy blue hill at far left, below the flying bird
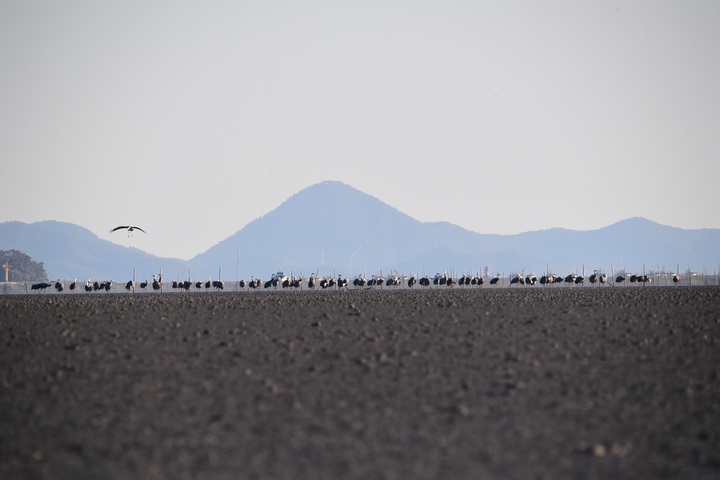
[[0, 221, 188, 282]]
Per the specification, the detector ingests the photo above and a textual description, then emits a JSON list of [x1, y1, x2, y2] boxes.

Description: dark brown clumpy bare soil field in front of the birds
[[0, 287, 720, 479]]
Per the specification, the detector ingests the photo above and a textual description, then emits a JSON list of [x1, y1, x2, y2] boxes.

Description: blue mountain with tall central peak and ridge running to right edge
[[190, 182, 720, 279]]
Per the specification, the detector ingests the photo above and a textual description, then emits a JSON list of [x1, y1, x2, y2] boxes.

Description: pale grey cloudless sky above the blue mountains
[[0, 0, 720, 259]]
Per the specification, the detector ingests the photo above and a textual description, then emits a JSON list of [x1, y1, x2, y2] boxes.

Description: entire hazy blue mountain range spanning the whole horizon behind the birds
[[0, 181, 720, 281]]
